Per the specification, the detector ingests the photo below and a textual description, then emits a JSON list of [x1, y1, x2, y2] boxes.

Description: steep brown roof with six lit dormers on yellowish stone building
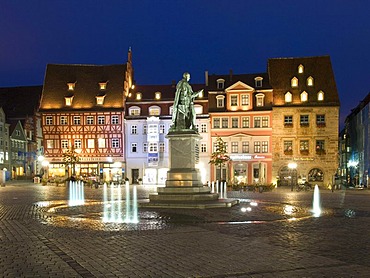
[[268, 56, 340, 106]]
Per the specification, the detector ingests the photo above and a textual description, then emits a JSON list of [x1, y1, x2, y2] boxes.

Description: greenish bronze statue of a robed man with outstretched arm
[[170, 72, 203, 131]]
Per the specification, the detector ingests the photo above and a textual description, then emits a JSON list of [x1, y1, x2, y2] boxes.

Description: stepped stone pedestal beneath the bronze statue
[[140, 130, 237, 208]]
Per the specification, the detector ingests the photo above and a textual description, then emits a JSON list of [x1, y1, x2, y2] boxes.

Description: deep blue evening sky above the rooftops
[[0, 0, 370, 126]]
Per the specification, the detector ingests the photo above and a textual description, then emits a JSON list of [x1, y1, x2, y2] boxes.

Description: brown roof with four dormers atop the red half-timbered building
[[39, 64, 127, 112]]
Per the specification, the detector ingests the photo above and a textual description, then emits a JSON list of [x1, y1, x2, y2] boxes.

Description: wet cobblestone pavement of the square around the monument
[[0, 182, 370, 277]]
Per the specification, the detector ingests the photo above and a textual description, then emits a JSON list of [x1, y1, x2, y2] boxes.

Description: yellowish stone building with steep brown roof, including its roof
[[268, 56, 340, 187]]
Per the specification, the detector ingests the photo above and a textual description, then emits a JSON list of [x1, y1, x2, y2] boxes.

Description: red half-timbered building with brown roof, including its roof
[[39, 51, 133, 181]]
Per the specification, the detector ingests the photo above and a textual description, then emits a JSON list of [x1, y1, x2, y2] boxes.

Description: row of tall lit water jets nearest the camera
[[103, 182, 139, 223]]
